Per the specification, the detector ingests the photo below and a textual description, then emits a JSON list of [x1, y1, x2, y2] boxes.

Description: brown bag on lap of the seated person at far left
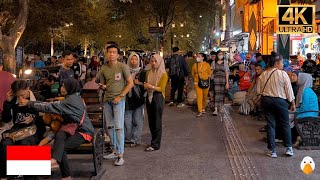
[[2, 125, 37, 142]]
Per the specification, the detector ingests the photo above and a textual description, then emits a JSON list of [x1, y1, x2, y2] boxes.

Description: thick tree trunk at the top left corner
[[0, 0, 29, 74]]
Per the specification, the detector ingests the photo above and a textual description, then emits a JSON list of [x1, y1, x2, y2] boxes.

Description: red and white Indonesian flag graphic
[[7, 146, 51, 175]]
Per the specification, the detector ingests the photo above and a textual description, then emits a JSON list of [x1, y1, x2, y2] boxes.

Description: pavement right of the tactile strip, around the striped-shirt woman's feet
[[229, 106, 320, 180]]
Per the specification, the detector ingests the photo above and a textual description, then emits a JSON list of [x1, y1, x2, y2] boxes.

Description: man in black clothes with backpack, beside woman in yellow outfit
[[167, 47, 189, 107]]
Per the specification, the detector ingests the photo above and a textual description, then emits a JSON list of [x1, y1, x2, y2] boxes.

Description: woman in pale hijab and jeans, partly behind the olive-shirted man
[[124, 53, 145, 147]]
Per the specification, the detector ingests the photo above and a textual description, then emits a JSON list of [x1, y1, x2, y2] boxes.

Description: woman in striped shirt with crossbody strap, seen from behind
[[257, 54, 296, 158]]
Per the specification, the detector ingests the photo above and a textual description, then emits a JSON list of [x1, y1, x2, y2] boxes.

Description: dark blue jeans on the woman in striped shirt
[[261, 96, 292, 151]]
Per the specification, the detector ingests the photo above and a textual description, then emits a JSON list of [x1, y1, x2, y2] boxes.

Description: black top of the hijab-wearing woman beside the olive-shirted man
[[126, 70, 146, 110]]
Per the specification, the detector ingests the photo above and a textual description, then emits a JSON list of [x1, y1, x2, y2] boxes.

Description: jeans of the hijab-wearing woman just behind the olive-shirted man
[[124, 105, 144, 143]]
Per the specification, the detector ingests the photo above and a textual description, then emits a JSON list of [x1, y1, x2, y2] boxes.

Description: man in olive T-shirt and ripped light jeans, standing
[[99, 45, 134, 166]]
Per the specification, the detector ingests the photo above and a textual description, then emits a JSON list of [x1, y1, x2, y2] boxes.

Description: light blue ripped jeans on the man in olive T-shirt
[[103, 100, 125, 154]]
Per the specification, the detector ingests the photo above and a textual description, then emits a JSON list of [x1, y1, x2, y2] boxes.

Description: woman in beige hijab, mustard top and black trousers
[[144, 54, 168, 151]]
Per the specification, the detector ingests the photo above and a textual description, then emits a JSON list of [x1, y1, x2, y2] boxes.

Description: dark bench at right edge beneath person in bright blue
[[294, 113, 320, 150]]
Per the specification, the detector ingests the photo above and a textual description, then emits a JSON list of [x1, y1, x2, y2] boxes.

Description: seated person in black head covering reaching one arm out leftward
[[20, 78, 94, 179]]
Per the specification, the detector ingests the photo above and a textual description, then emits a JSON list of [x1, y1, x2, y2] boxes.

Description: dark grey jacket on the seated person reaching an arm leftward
[[28, 94, 94, 136]]
